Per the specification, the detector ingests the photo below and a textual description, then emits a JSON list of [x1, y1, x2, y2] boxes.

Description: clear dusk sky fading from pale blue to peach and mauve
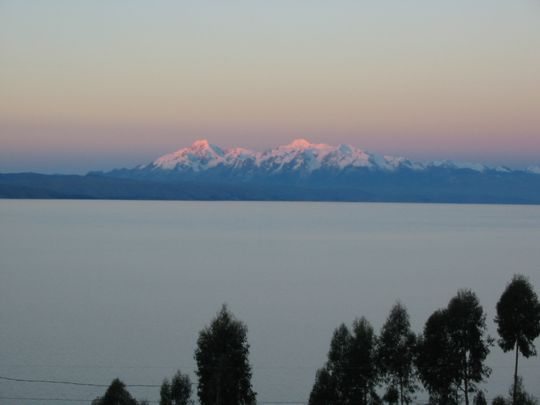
[[0, 0, 540, 173]]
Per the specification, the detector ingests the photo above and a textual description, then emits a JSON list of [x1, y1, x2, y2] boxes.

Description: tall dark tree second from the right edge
[[447, 290, 492, 405]]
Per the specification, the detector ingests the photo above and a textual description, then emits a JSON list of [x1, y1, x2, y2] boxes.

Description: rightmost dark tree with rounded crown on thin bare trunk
[[495, 275, 540, 404]]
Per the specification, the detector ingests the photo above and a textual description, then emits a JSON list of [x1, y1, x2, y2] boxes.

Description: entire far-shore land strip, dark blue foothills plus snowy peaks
[[0, 139, 540, 204]]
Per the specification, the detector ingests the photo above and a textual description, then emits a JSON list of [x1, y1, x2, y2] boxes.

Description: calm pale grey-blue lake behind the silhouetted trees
[[0, 200, 540, 405]]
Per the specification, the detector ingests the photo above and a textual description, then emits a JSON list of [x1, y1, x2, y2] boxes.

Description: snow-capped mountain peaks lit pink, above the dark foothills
[[120, 139, 540, 176]]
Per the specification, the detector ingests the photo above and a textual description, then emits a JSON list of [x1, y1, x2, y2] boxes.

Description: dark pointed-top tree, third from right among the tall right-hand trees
[[377, 302, 416, 405]]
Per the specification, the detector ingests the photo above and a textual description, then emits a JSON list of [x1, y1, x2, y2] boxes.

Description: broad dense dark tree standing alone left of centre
[[195, 305, 256, 405]]
